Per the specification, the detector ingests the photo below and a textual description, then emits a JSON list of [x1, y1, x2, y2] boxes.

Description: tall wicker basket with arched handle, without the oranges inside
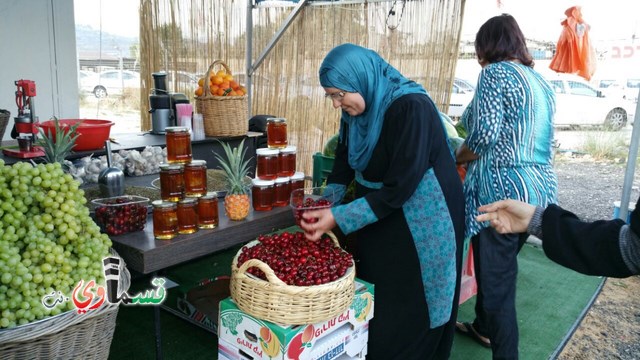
[[196, 60, 249, 137]]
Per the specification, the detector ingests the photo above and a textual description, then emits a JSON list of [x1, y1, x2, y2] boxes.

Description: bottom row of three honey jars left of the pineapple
[[152, 192, 219, 240]]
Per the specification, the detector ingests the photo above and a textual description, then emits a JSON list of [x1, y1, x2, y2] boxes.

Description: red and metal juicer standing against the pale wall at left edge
[[2, 79, 44, 159]]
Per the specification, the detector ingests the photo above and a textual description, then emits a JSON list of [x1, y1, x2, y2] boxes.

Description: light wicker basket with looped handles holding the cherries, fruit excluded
[[230, 233, 355, 325]]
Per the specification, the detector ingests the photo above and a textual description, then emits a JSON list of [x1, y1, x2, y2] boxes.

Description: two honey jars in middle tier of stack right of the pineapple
[[256, 146, 296, 180]]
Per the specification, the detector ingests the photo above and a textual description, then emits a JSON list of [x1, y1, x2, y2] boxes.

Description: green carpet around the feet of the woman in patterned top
[[451, 245, 603, 360]]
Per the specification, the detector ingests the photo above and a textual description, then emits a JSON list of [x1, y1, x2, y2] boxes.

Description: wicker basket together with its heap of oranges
[[195, 60, 249, 137]]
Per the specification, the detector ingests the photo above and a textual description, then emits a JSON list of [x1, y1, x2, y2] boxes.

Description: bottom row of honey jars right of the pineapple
[[251, 172, 304, 211]]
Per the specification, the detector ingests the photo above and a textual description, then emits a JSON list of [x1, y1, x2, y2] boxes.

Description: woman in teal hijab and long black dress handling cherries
[[301, 44, 464, 360]]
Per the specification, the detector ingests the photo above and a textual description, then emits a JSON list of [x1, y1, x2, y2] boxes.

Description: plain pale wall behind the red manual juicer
[[0, 0, 78, 139]]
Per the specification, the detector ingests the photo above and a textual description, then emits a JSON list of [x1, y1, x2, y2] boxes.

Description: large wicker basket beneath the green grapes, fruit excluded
[[0, 252, 131, 360]]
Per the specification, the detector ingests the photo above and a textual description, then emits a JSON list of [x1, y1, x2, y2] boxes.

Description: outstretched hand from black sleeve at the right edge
[[476, 199, 536, 234]]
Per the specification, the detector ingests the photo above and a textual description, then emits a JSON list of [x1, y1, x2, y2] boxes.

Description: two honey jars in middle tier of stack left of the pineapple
[[160, 160, 207, 202]]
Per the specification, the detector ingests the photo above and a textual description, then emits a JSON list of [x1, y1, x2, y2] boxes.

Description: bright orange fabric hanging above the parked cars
[[549, 6, 596, 80]]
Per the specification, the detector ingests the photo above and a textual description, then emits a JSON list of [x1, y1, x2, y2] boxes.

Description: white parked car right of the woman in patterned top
[[547, 74, 634, 130]]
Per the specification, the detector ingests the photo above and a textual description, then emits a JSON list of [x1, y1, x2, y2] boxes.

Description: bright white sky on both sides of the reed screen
[[74, 0, 640, 41]]
